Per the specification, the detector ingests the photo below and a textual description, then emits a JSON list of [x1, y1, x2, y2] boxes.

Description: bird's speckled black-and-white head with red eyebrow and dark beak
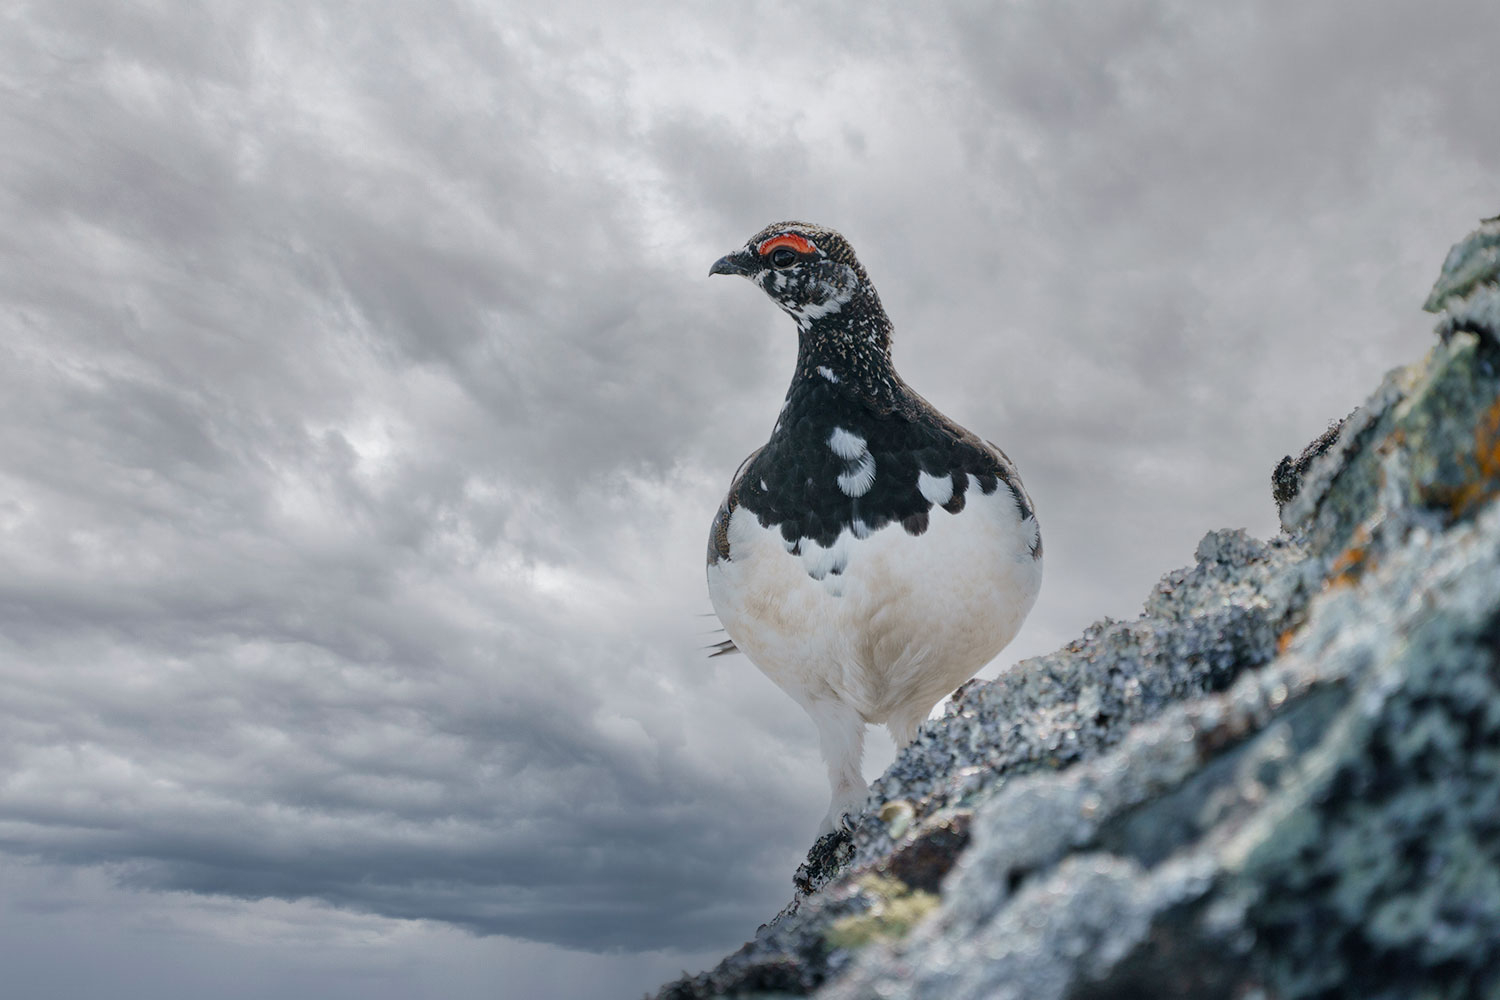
[[708, 222, 873, 328]]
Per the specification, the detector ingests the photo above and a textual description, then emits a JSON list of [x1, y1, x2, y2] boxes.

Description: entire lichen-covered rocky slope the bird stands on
[[659, 220, 1500, 1000]]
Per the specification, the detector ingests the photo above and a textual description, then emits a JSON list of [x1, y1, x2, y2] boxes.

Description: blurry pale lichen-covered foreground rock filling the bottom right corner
[[819, 488, 1500, 1000]]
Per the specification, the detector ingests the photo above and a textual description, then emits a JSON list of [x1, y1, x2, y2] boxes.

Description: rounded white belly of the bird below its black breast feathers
[[708, 474, 1041, 727]]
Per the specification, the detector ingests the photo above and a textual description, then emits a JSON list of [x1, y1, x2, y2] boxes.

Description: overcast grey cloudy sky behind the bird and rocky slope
[[0, 0, 1500, 1000]]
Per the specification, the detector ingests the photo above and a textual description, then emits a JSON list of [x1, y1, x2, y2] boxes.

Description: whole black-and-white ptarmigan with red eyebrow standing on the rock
[[708, 222, 1043, 832]]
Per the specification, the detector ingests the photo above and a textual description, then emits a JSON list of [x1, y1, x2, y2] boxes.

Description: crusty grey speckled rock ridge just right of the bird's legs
[[854, 531, 1316, 865]]
